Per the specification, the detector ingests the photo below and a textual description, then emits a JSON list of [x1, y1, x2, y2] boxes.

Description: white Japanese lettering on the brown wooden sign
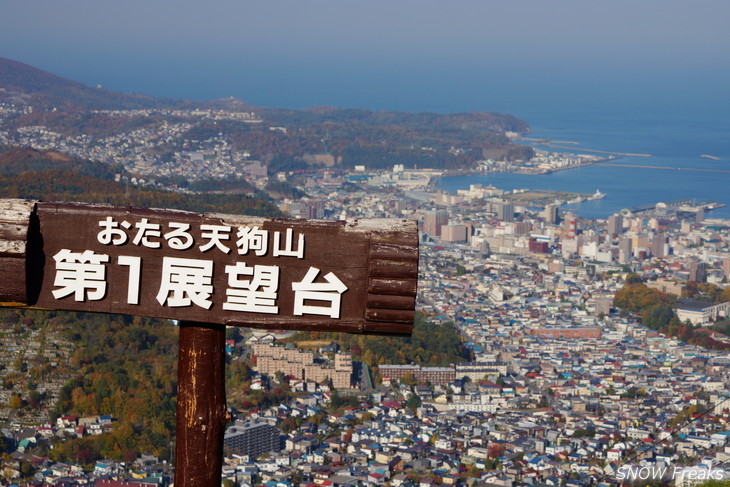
[[52, 216, 348, 318]]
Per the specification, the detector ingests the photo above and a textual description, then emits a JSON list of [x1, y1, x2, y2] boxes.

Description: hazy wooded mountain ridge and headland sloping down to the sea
[[0, 58, 533, 173]]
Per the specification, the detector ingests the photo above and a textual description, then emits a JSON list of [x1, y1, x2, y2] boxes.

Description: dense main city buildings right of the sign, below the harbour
[[199, 166, 730, 486]]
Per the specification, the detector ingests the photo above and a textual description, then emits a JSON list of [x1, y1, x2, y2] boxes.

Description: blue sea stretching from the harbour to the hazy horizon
[[82, 59, 730, 223]]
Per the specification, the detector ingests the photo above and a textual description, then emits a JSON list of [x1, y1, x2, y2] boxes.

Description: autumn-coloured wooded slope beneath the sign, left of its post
[[0, 309, 177, 465]]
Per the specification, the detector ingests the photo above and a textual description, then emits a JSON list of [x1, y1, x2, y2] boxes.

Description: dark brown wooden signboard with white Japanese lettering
[[0, 200, 418, 334]]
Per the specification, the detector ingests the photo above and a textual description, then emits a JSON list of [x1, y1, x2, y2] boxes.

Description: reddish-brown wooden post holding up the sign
[[175, 322, 231, 487]]
